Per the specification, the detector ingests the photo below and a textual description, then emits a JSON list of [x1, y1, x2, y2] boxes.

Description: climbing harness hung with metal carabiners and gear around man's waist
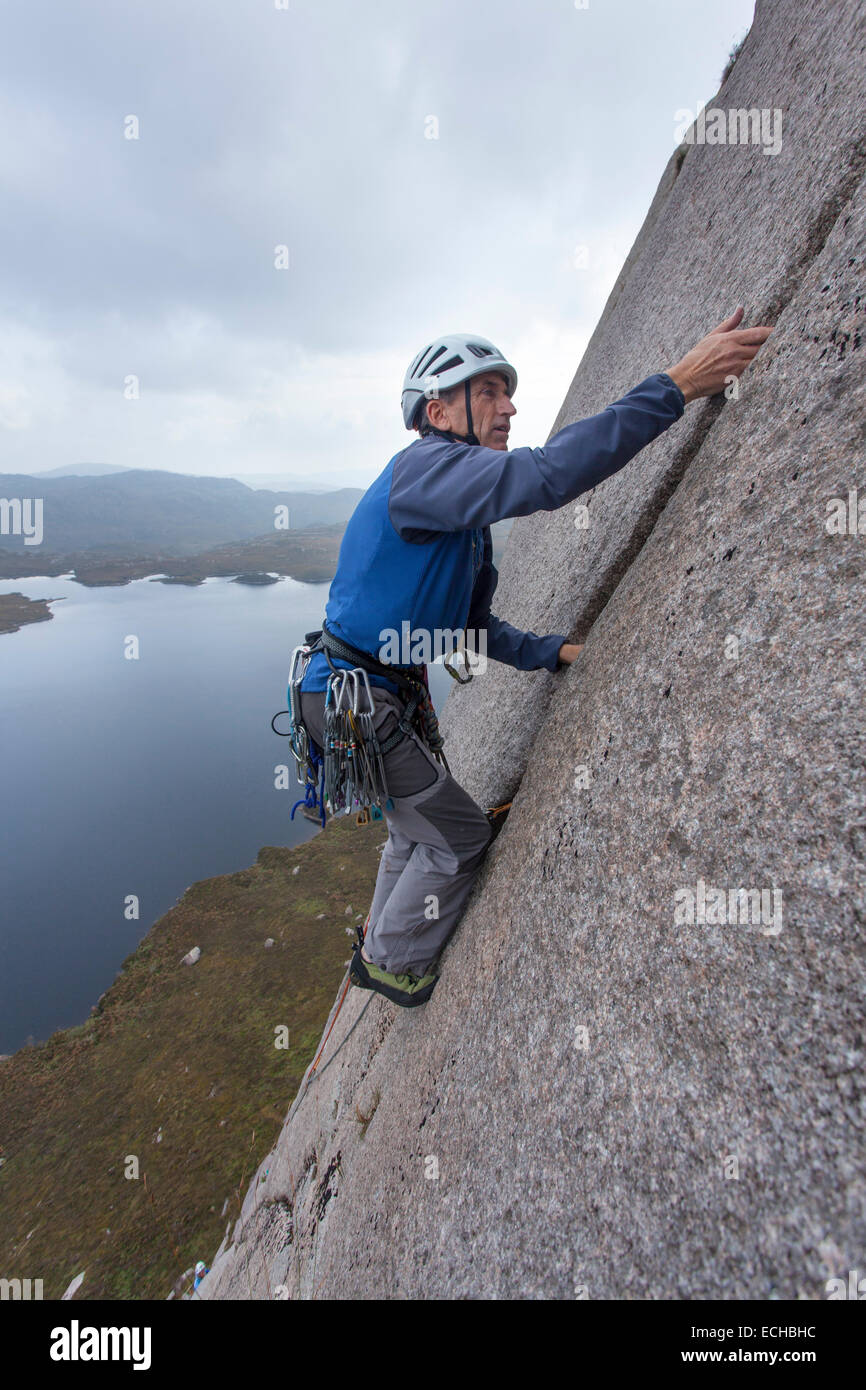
[[271, 624, 450, 826]]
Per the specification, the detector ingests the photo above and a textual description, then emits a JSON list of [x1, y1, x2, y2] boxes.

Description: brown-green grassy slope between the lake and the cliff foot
[[0, 816, 386, 1300]]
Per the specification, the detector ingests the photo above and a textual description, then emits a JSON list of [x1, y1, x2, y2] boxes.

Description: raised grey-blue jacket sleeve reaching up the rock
[[389, 373, 685, 539]]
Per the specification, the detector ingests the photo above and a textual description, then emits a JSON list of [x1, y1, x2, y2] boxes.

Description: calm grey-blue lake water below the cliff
[[0, 578, 450, 1054]]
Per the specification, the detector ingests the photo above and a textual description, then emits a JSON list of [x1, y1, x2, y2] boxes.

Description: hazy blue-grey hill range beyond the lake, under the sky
[[0, 466, 363, 555]]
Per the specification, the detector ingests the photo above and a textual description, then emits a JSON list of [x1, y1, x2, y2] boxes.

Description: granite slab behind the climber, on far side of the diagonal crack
[[442, 0, 866, 805]]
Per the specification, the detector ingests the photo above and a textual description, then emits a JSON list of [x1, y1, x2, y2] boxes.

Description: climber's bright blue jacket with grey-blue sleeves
[[302, 373, 685, 694]]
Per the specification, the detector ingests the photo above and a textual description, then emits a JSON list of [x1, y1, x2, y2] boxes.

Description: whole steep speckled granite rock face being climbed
[[200, 0, 866, 1298]]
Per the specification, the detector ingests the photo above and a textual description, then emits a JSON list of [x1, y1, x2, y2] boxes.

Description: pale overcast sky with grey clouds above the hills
[[0, 0, 753, 487]]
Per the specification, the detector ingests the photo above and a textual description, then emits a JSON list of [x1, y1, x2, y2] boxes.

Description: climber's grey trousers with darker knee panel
[[300, 685, 492, 976]]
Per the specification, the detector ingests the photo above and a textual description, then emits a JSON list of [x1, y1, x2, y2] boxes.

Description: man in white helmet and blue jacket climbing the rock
[[300, 309, 770, 1006]]
